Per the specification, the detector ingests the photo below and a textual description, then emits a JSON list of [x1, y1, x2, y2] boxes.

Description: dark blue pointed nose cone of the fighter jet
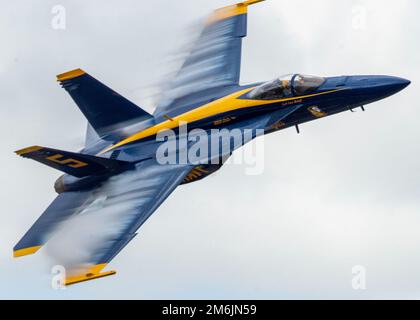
[[348, 76, 411, 103]]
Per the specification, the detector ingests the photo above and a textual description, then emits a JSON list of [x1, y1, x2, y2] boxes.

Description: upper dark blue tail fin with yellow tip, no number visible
[[57, 69, 152, 138]]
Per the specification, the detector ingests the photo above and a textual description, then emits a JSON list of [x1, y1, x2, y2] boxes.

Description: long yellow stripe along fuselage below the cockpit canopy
[[99, 87, 342, 155]]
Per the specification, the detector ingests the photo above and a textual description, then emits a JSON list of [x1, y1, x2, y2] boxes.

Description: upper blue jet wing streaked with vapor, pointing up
[[155, 0, 264, 117]]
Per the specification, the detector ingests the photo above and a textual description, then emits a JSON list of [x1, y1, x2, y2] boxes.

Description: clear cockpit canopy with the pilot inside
[[249, 74, 325, 100]]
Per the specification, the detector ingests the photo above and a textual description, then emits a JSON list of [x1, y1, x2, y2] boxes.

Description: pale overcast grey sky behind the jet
[[0, 0, 420, 299]]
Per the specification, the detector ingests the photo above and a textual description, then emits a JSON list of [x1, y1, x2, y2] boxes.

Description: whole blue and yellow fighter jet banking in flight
[[14, 0, 410, 285]]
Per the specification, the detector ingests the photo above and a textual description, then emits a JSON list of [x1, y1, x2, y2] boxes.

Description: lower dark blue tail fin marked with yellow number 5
[[16, 146, 129, 178]]
